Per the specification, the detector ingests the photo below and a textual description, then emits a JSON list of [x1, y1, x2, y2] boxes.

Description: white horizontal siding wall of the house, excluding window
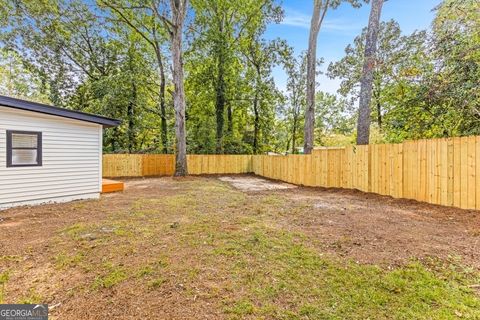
[[0, 106, 102, 209]]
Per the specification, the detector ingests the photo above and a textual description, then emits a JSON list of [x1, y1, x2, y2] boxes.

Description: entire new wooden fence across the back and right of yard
[[103, 136, 480, 209]]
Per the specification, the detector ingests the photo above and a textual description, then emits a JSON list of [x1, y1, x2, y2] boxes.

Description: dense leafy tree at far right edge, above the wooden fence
[[378, 0, 480, 142]]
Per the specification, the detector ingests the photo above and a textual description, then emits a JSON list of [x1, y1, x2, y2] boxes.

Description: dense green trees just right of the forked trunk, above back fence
[[185, 0, 285, 153]]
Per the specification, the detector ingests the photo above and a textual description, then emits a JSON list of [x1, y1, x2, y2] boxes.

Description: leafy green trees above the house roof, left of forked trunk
[[0, 0, 167, 152]]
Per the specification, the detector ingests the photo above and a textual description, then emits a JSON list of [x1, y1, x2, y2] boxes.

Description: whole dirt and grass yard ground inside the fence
[[0, 176, 480, 319]]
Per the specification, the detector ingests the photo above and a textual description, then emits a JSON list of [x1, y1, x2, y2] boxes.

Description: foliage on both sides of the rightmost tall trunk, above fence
[[329, 0, 480, 142]]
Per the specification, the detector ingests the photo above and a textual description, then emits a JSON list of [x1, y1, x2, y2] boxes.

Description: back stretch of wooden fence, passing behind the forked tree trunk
[[103, 154, 253, 178]]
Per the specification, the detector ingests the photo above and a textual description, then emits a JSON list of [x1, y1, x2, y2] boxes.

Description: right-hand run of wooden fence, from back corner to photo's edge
[[253, 137, 480, 209]]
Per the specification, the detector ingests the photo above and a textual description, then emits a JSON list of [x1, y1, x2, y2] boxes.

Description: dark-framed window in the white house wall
[[7, 130, 42, 167]]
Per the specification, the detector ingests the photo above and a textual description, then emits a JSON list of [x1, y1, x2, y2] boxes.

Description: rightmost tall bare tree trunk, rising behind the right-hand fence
[[357, 0, 383, 145]]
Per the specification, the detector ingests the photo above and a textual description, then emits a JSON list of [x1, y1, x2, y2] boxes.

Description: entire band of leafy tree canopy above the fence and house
[[0, 0, 480, 154]]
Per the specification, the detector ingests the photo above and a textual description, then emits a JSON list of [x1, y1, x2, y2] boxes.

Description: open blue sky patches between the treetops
[[265, 0, 441, 93]]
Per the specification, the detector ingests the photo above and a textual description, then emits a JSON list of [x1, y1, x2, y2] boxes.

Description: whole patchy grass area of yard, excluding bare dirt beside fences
[[0, 178, 480, 319]]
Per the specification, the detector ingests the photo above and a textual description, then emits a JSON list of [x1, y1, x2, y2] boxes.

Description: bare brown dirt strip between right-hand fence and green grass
[[278, 188, 480, 269]]
